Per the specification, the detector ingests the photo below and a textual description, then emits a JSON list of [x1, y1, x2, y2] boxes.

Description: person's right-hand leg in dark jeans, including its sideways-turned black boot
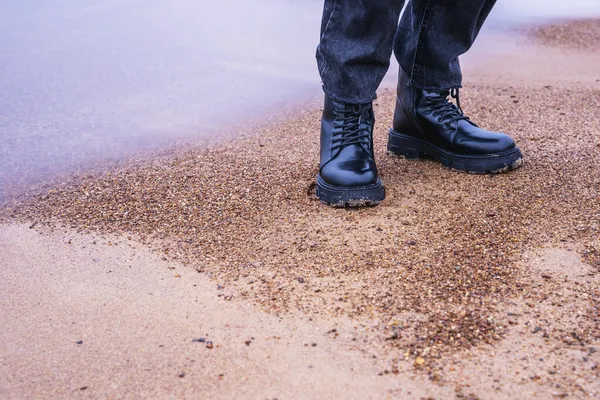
[[388, 0, 523, 173]]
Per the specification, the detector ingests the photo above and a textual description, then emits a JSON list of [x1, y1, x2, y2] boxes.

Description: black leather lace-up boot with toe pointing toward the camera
[[317, 95, 385, 207]]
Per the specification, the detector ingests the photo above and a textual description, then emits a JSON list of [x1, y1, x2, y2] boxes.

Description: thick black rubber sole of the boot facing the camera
[[316, 175, 385, 207]]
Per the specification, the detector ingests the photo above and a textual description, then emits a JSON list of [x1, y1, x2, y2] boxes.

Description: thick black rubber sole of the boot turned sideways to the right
[[388, 129, 523, 174]]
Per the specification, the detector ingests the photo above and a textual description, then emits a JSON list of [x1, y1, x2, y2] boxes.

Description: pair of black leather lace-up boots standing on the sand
[[316, 71, 523, 207]]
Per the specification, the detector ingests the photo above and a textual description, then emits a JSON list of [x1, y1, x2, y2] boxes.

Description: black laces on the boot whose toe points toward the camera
[[331, 104, 373, 157]]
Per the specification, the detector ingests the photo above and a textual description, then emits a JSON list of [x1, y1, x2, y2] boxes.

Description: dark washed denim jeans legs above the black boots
[[317, 0, 496, 104]]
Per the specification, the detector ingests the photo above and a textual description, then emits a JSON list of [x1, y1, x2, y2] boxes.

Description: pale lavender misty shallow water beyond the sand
[[0, 0, 600, 198]]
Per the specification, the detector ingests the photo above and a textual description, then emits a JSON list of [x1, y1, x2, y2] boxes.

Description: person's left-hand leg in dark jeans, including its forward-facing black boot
[[316, 0, 404, 206]]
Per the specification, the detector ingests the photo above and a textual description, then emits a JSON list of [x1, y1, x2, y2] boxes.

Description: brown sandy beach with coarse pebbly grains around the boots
[[0, 20, 600, 400]]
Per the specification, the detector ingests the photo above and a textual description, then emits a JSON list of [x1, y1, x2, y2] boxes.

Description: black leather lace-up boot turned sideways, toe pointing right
[[388, 70, 523, 174]]
